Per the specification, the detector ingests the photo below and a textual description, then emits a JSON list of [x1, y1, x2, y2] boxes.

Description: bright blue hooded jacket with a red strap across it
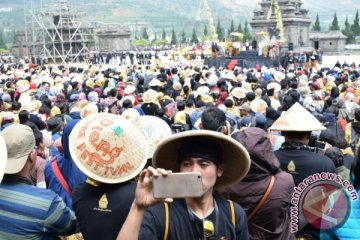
[[45, 120, 86, 209]]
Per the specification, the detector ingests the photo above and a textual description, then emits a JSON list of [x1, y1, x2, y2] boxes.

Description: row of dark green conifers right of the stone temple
[[312, 10, 360, 44]]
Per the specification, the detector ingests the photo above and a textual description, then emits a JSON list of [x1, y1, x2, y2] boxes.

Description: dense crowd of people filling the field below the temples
[[0, 53, 360, 239]]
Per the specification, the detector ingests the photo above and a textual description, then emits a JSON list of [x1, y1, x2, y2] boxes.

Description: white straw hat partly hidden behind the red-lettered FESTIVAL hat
[[135, 116, 171, 158]]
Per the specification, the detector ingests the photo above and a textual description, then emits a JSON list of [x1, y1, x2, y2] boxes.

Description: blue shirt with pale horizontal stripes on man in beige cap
[[0, 175, 76, 240]]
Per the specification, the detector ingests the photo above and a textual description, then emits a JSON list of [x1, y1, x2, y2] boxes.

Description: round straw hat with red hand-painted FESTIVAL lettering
[[69, 113, 147, 183]]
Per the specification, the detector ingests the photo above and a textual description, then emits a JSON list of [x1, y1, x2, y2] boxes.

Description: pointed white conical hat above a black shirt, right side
[[269, 103, 326, 132]]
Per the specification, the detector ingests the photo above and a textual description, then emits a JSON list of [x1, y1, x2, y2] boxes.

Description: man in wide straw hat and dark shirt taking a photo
[[118, 130, 250, 240]]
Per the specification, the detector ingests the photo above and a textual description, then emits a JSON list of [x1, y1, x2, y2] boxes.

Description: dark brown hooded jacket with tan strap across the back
[[223, 127, 294, 239]]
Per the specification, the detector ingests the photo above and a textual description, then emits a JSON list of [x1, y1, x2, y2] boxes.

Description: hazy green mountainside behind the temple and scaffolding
[[0, 0, 360, 35]]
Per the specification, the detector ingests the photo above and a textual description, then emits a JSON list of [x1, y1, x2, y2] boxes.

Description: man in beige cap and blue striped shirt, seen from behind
[[0, 124, 76, 239]]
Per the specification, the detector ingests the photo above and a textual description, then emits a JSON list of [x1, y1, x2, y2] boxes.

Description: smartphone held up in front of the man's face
[[153, 172, 203, 198]]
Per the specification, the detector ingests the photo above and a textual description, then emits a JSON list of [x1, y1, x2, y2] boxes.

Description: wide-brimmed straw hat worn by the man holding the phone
[[152, 130, 251, 188]]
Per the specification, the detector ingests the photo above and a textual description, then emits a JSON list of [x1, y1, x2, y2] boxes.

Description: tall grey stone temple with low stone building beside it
[[250, 0, 346, 52]]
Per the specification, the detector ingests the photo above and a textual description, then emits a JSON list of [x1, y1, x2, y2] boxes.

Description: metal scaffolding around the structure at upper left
[[24, 0, 95, 64]]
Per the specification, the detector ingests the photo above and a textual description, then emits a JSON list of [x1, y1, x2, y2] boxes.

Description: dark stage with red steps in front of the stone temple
[[204, 51, 280, 70]]
